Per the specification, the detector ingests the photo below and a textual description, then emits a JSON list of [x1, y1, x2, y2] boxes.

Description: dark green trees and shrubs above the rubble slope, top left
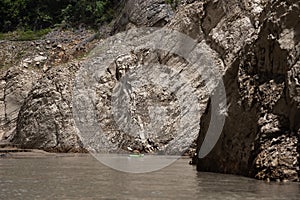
[[0, 0, 122, 32]]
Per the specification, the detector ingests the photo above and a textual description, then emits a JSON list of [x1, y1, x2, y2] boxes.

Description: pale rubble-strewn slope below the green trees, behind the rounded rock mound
[[0, 30, 95, 149]]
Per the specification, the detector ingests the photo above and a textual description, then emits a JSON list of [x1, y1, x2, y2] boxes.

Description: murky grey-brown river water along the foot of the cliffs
[[0, 155, 300, 200]]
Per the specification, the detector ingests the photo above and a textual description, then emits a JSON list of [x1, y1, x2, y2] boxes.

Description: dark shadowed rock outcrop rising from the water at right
[[197, 1, 300, 181]]
